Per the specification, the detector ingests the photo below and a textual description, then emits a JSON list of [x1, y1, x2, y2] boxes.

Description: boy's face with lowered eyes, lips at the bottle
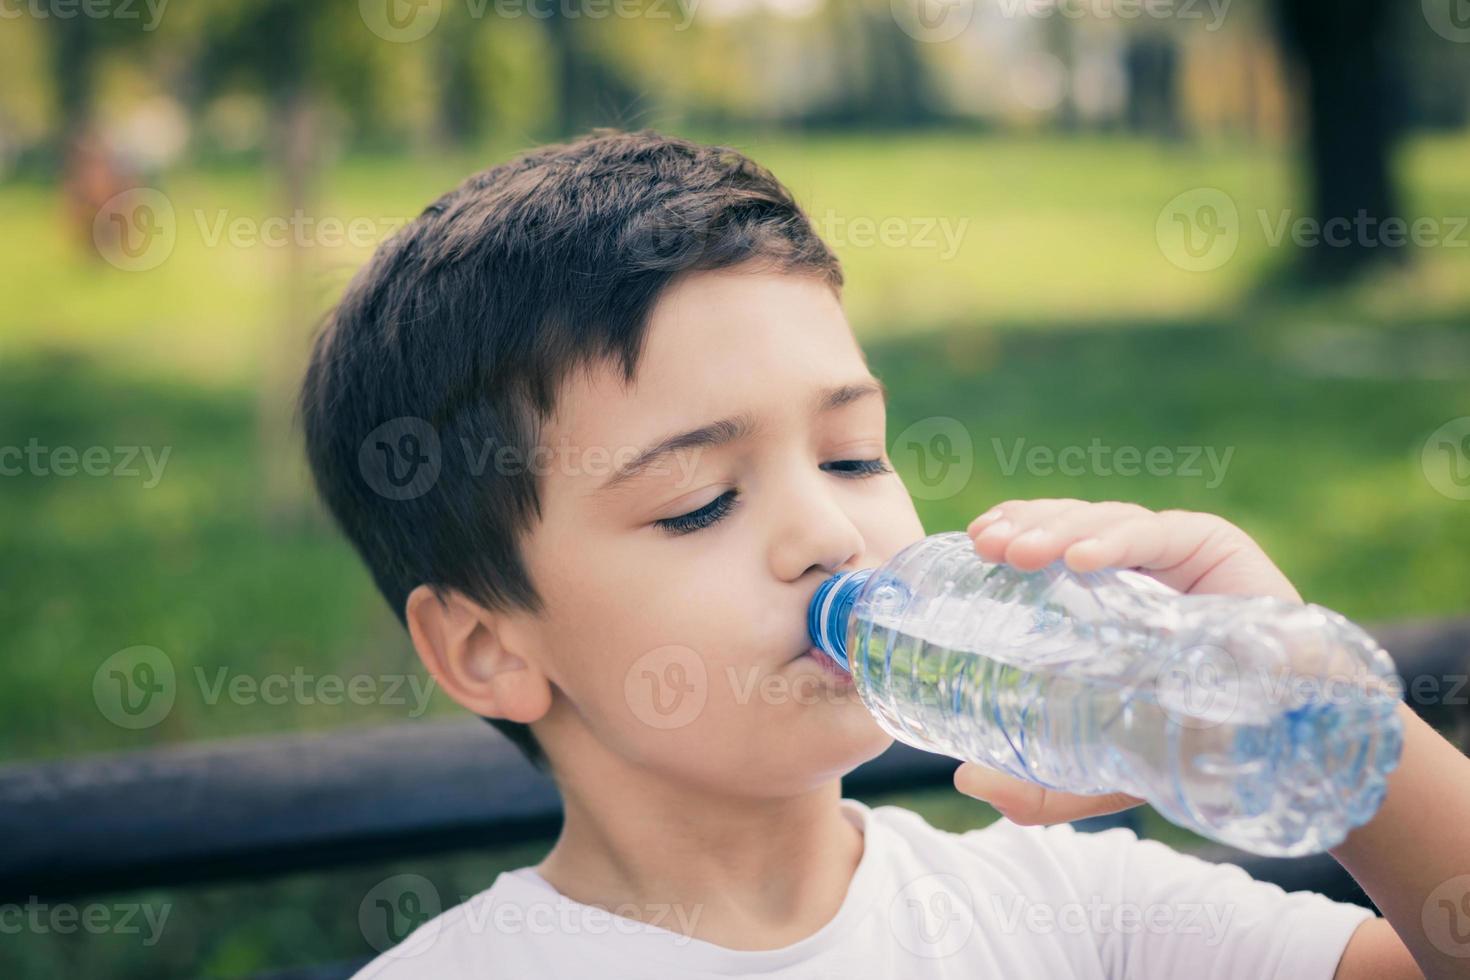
[[525, 269, 925, 795]]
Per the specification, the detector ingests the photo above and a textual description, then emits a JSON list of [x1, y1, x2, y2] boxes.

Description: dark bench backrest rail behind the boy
[[0, 619, 1470, 980]]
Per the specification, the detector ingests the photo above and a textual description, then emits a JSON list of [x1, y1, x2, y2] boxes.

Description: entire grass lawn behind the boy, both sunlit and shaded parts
[[0, 128, 1470, 976]]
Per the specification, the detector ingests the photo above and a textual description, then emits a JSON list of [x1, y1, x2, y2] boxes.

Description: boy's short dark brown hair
[[298, 129, 842, 771]]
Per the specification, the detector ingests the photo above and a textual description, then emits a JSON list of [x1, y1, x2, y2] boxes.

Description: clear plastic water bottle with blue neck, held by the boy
[[807, 532, 1402, 857]]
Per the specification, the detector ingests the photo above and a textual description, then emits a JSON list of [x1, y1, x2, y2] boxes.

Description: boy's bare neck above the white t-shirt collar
[[537, 752, 863, 949]]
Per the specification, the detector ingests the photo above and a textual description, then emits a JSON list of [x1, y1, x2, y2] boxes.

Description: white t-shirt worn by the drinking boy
[[349, 799, 1373, 980]]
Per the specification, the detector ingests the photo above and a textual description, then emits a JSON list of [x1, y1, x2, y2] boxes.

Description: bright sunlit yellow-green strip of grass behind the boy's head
[[11, 134, 1470, 383]]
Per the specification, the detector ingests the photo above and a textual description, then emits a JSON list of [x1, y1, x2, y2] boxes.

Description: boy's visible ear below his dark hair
[[404, 585, 551, 723]]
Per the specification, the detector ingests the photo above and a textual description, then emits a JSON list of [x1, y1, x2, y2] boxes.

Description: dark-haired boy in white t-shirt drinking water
[[301, 129, 1470, 980]]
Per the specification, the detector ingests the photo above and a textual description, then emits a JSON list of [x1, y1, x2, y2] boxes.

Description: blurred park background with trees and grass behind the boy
[[0, 0, 1470, 977]]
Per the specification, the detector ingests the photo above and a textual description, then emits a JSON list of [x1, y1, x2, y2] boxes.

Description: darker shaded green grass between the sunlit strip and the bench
[[0, 310, 1470, 758]]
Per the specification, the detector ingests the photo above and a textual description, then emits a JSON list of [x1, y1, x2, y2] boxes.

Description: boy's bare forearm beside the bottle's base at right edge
[[1332, 704, 1470, 977]]
